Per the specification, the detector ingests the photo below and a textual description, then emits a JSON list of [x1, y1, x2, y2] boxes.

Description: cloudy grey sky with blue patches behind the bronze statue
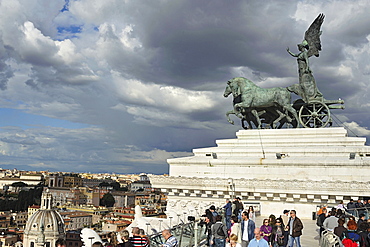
[[0, 0, 370, 174]]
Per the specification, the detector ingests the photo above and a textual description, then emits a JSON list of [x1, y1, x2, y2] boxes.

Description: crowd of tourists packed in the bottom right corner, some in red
[[316, 199, 370, 247]]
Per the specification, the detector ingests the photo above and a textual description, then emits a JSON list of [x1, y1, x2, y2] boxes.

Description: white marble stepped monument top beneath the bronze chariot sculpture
[[150, 127, 370, 218]]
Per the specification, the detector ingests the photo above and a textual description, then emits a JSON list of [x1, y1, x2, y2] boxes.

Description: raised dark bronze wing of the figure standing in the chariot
[[304, 13, 325, 57]]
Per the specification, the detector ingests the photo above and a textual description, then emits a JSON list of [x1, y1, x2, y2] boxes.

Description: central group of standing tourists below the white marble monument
[[204, 197, 303, 247]]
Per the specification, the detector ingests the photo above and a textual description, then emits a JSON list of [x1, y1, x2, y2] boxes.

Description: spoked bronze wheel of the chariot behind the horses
[[298, 101, 331, 128]]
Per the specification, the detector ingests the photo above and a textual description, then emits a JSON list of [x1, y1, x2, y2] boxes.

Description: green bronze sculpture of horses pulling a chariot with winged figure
[[224, 14, 344, 129]]
